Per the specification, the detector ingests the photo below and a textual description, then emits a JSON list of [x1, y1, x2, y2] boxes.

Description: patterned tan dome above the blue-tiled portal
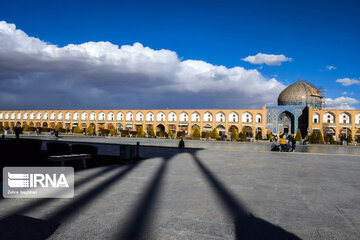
[[278, 81, 323, 109]]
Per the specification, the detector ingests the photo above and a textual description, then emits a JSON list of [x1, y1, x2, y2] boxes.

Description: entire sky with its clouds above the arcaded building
[[0, 0, 360, 110]]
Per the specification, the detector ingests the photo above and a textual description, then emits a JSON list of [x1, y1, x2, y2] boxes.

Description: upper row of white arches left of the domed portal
[[0, 111, 263, 123]]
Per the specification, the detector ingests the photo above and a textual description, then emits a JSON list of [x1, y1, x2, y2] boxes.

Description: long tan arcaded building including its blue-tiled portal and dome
[[0, 81, 360, 140]]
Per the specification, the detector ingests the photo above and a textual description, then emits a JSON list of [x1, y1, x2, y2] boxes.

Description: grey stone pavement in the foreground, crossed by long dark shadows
[[0, 149, 360, 240]]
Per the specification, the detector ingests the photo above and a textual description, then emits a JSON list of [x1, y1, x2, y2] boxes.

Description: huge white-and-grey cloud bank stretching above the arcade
[[0, 21, 285, 108]]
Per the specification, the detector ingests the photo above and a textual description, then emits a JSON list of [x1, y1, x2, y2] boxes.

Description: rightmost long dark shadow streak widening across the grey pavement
[[193, 154, 300, 240]]
